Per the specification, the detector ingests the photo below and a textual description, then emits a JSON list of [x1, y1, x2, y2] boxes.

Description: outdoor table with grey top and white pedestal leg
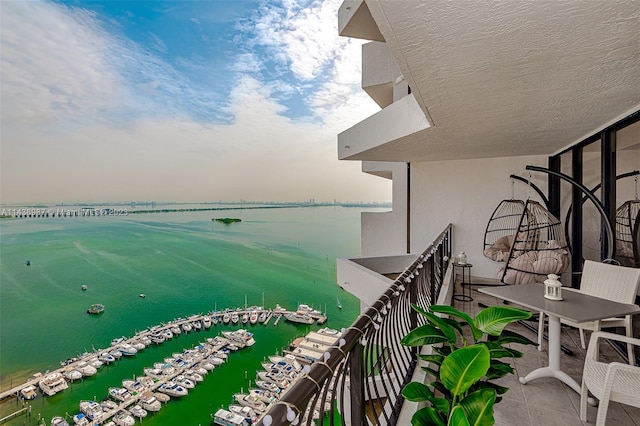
[[478, 283, 640, 405]]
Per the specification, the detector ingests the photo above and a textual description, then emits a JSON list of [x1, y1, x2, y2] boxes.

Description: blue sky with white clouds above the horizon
[[0, 0, 391, 204]]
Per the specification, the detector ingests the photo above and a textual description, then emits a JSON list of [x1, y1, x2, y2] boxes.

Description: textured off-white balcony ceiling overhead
[[360, 0, 640, 161]]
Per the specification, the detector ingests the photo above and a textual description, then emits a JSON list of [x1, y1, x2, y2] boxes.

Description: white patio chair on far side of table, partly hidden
[[538, 260, 640, 365]]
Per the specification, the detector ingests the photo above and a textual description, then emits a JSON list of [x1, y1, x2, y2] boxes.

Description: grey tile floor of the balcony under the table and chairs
[[453, 280, 640, 426]]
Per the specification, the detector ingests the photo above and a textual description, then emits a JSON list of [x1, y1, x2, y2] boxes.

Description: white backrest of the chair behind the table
[[580, 260, 640, 303]]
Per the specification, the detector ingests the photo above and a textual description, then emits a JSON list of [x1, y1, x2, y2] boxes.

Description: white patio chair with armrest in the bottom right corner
[[580, 331, 640, 426]]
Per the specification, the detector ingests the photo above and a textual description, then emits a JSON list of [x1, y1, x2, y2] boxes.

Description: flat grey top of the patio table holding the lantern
[[478, 283, 640, 323]]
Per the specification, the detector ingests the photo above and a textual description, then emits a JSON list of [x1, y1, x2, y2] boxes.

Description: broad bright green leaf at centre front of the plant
[[440, 344, 490, 396]]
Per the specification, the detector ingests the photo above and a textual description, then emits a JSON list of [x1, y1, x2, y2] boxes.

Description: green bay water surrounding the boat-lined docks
[[0, 207, 373, 425]]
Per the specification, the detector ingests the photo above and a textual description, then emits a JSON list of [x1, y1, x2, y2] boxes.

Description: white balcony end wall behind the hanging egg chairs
[[410, 156, 548, 278]]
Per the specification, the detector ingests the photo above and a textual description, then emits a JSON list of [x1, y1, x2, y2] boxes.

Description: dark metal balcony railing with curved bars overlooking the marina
[[258, 225, 452, 426]]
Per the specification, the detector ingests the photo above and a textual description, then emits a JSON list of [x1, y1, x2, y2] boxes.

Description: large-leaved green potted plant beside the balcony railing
[[402, 305, 537, 426]]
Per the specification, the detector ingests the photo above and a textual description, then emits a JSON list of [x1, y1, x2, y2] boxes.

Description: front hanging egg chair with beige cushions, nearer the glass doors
[[498, 199, 571, 284]]
